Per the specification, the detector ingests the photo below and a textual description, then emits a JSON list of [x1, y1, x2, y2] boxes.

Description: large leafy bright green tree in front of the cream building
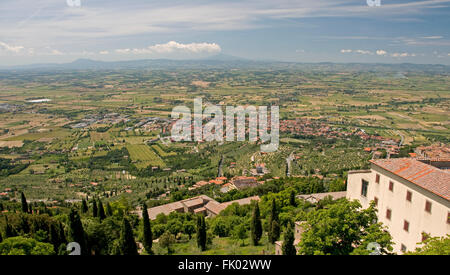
[[300, 199, 392, 255]]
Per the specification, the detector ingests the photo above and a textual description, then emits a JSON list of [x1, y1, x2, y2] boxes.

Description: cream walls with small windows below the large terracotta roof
[[347, 163, 450, 254]]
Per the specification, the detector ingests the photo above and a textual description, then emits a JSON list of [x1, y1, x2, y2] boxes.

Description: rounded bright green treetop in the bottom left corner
[[0, 236, 55, 255]]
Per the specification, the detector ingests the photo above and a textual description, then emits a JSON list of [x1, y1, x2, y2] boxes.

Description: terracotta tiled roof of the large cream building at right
[[370, 158, 450, 200]]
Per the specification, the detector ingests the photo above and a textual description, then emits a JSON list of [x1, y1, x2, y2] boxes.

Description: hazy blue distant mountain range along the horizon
[[0, 57, 450, 73]]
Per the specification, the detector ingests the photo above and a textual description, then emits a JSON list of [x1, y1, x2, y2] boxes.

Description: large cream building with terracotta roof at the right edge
[[347, 158, 450, 253]]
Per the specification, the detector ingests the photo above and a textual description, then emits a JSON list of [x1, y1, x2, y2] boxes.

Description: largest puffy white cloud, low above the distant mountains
[[115, 41, 222, 54]]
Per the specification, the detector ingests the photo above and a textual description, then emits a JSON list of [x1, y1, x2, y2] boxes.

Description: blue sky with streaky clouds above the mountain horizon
[[0, 0, 450, 66]]
